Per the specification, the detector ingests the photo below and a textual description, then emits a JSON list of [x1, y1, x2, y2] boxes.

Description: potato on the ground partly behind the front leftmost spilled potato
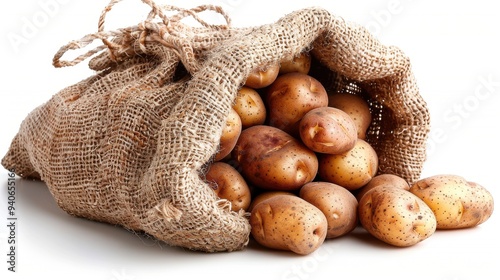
[[299, 182, 358, 239]]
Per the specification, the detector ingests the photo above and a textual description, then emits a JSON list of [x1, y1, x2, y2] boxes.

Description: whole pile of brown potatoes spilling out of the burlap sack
[[202, 53, 493, 255]]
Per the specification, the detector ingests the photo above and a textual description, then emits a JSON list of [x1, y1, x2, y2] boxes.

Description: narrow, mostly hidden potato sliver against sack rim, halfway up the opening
[[215, 108, 243, 161]]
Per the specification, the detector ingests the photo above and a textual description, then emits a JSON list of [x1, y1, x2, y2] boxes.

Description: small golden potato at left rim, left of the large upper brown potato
[[233, 87, 267, 129]]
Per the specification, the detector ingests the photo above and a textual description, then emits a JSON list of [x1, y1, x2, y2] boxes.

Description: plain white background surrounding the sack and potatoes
[[0, 0, 500, 280]]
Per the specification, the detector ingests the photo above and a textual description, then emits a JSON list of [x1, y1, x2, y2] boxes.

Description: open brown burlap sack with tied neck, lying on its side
[[2, 0, 429, 252]]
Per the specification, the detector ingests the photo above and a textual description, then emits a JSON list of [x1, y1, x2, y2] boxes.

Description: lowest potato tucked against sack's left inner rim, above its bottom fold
[[205, 162, 251, 211]]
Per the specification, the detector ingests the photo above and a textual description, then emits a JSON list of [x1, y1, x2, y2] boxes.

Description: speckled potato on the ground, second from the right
[[358, 186, 436, 247]]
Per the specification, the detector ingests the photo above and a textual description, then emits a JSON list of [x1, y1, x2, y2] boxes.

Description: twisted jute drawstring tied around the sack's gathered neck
[[52, 0, 231, 73]]
